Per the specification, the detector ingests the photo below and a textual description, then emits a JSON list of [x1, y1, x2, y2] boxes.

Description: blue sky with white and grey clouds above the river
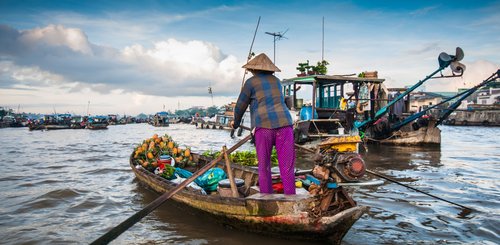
[[0, 0, 500, 115]]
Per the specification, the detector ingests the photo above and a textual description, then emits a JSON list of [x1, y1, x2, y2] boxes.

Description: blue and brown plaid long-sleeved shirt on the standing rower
[[234, 74, 293, 129]]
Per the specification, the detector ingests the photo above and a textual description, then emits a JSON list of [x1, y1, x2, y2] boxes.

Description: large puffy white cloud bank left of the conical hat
[[0, 25, 243, 96]]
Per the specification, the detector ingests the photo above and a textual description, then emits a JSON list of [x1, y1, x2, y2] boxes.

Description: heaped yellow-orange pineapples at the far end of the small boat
[[134, 134, 196, 171]]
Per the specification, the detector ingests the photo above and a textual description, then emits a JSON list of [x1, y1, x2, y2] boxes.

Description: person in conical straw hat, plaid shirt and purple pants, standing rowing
[[231, 53, 295, 195]]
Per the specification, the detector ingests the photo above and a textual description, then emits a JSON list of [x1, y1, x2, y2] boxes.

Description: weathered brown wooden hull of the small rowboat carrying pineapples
[[130, 154, 369, 244]]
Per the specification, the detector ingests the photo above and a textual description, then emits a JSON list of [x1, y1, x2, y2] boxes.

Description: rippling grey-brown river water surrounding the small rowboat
[[0, 124, 500, 245]]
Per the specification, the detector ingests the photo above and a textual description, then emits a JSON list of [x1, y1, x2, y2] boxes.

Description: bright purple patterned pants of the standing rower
[[255, 126, 295, 195]]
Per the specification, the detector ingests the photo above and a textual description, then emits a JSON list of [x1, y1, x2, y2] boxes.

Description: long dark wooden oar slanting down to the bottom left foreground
[[91, 135, 252, 244]]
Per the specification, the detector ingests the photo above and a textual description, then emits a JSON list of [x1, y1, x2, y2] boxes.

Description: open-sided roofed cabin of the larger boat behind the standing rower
[[282, 75, 384, 143]]
